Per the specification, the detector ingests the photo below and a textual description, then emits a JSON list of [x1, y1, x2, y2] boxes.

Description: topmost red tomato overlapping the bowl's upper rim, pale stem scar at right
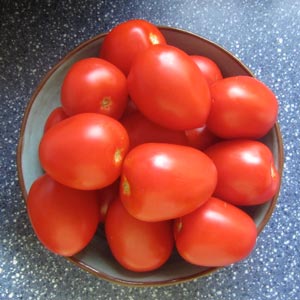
[[99, 20, 166, 75]]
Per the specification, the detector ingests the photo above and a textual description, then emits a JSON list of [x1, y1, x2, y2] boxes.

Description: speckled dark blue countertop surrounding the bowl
[[0, 0, 300, 300]]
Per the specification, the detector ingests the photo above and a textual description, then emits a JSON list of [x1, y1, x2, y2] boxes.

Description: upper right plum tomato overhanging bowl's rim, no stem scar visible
[[207, 76, 278, 139]]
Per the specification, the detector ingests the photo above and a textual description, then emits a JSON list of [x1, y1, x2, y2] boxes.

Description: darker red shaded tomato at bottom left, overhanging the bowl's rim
[[27, 174, 99, 256]]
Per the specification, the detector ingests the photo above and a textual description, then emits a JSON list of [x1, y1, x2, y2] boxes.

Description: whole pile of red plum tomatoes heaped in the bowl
[[27, 20, 279, 272]]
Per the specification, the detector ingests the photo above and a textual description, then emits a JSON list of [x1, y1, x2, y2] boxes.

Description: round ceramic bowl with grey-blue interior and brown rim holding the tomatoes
[[17, 26, 283, 286]]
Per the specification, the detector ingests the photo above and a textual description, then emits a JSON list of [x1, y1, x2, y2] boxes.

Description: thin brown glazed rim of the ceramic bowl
[[16, 25, 284, 287]]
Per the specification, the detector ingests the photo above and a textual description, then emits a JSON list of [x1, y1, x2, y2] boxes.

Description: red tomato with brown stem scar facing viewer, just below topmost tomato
[[61, 57, 128, 119]]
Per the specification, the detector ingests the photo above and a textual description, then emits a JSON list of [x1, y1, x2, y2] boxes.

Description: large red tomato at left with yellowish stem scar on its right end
[[39, 113, 129, 190]]
